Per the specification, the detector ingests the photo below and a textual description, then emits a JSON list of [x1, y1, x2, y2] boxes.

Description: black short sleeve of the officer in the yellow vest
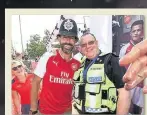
[[111, 55, 126, 89]]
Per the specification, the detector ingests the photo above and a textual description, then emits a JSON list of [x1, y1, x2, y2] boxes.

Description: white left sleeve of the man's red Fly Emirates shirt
[[34, 52, 51, 78]]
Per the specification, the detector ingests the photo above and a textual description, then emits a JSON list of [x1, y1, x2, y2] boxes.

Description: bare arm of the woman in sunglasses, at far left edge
[[12, 90, 21, 114]]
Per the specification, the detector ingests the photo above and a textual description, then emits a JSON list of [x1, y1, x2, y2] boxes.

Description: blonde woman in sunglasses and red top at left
[[11, 60, 40, 114]]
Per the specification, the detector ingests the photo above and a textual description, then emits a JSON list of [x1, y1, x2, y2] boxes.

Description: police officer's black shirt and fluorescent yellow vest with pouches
[[73, 53, 125, 114]]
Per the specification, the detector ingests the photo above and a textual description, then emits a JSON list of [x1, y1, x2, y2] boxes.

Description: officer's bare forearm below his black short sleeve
[[116, 88, 131, 115]]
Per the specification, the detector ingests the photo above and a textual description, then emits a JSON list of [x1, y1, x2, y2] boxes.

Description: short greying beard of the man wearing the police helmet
[[60, 43, 74, 54]]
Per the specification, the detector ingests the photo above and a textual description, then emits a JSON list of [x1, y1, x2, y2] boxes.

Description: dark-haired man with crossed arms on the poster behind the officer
[[119, 20, 144, 114]]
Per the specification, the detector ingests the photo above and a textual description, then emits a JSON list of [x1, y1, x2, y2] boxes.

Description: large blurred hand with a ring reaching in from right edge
[[119, 40, 147, 93]]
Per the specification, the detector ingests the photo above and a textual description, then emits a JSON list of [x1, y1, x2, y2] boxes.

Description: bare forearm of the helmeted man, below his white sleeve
[[30, 75, 41, 111]]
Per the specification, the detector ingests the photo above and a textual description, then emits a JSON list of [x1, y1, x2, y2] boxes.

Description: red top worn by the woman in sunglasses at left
[[12, 74, 34, 104]]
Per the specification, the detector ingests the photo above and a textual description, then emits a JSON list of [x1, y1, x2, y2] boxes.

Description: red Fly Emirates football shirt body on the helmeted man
[[36, 51, 80, 114]]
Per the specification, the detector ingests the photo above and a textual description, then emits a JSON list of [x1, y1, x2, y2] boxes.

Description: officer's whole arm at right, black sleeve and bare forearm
[[111, 56, 131, 115]]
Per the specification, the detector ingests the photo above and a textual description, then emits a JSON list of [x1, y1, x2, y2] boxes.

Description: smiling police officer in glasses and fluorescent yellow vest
[[72, 33, 130, 115]]
